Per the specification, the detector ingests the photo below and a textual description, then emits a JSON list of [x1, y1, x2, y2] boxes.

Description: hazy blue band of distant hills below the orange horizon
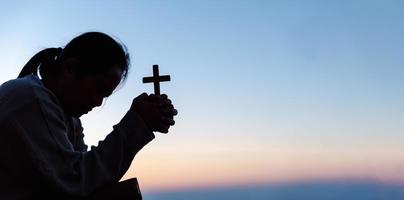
[[143, 182, 404, 200]]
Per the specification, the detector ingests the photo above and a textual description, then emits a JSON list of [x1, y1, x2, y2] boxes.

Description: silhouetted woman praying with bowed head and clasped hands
[[0, 32, 177, 199]]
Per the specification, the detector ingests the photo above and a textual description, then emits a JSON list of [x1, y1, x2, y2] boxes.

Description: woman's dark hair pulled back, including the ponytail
[[18, 32, 130, 80]]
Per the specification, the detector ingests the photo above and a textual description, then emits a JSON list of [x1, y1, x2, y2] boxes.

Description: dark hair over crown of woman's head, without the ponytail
[[40, 32, 129, 79]]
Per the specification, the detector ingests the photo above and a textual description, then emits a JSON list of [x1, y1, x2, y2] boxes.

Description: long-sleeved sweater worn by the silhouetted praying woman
[[0, 75, 155, 200]]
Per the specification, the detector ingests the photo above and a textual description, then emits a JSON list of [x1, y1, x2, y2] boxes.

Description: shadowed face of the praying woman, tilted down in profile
[[57, 57, 122, 117]]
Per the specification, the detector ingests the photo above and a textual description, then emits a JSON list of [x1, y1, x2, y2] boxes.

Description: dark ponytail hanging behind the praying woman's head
[[18, 48, 62, 78]]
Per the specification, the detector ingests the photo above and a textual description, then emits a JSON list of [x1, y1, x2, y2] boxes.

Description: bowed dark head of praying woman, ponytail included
[[19, 32, 129, 117]]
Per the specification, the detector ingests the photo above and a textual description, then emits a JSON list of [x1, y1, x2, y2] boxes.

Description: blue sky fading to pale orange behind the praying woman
[[0, 0, 404, 197]]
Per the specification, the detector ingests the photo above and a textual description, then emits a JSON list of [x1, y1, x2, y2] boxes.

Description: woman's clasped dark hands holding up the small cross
[[130, 93, 178, 133]]
